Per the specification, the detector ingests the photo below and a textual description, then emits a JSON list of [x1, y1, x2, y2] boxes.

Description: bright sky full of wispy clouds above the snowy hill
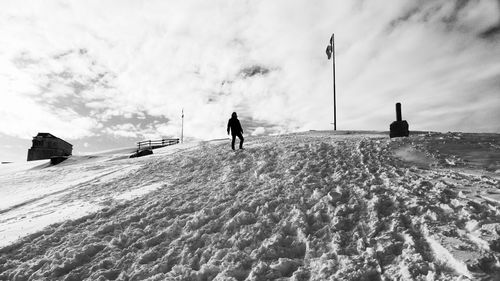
[[0, 0, 500, 161]]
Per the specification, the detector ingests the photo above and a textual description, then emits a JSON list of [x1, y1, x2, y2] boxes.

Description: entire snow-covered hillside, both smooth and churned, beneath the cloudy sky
[[0, 132, 500, 280]]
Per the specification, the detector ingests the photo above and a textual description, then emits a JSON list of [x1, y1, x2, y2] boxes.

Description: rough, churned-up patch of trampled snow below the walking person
[[0, 132, 500, 280]]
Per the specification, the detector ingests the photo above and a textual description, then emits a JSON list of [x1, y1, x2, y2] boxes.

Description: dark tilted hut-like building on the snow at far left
[[28, 133, 73, 161]]
